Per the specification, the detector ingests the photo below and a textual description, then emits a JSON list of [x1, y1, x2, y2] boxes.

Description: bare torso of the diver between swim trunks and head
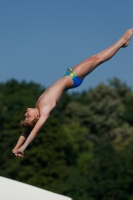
[[36, 76, 73, 116]]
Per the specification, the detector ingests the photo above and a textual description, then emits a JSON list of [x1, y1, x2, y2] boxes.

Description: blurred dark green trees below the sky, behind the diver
[[0, 78, 133, 200]]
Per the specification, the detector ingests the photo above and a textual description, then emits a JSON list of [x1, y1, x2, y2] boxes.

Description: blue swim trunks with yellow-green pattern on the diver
[[64, 68, 83, 88]]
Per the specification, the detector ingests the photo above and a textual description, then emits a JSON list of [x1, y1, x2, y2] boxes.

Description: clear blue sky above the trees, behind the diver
[[0, 0, 133, 91]]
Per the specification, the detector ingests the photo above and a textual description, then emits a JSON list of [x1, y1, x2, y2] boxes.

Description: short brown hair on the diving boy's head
[[20, 118, 38, 131]]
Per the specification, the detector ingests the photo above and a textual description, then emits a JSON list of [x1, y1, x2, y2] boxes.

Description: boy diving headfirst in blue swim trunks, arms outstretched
[[12, 29, 133, 157]]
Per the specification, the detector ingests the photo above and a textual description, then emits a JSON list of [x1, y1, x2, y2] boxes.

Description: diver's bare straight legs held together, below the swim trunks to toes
[[74, 29, 133, 78]]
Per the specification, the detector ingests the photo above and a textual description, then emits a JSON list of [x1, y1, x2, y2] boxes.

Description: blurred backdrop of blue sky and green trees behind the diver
[[0, 0, 133, 200]]
